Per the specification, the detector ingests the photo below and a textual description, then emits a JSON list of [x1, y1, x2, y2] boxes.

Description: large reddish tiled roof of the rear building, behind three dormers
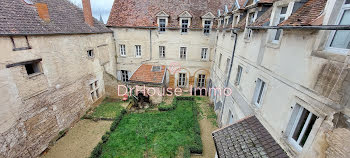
[[107, 0, 234, 28]]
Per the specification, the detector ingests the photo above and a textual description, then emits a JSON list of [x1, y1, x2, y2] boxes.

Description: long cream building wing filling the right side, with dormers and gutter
[[210, 0, 350, 157]]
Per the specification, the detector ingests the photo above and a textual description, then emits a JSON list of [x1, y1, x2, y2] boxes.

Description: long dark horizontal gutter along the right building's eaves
[[247, 25, 350, 30]]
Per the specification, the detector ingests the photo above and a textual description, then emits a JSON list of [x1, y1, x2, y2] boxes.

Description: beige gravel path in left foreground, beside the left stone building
[[41, 120, 112, 158]]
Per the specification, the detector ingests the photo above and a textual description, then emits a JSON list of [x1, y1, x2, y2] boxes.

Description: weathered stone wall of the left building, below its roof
[[0, 33, 116, 157]]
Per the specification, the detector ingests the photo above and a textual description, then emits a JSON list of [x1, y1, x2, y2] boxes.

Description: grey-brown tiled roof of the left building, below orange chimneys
[[0, 0, 111, 35]]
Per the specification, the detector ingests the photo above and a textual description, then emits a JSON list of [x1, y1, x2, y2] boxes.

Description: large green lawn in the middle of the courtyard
[[101, 100, 202, 158]]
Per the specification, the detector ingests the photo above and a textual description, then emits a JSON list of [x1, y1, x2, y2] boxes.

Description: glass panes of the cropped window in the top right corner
[[331, 10, 350, 49]]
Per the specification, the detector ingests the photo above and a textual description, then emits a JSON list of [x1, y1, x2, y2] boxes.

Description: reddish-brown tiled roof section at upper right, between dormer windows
[[279, 0, 327, 26]]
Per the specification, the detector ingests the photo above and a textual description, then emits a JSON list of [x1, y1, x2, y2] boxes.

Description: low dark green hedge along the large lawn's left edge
[[90, 109, 127, 158]]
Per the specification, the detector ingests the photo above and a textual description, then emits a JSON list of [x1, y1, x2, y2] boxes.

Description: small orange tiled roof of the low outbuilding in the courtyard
[[130, 64, 166, 84]]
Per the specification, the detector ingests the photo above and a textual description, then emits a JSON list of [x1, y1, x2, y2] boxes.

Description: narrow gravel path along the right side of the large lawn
[[191, 97, 217, 158]]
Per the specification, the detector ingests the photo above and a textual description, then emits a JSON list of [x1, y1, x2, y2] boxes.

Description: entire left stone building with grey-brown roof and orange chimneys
[[0, 0, 116, 157]]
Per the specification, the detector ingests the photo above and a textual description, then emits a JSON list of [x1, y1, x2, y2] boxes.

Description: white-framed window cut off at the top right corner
[[329, 0, 350, 50]]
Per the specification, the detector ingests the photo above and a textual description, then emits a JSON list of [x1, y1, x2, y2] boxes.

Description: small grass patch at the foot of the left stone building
[[91, 101, 124, 118]]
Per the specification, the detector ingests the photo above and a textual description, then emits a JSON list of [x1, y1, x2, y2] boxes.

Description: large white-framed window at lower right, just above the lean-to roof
[[288, 104, 317, 150]]
